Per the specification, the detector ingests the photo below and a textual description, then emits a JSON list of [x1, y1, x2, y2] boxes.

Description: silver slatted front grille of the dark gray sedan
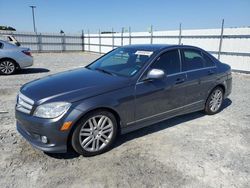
[[16, 93, 34, 114]]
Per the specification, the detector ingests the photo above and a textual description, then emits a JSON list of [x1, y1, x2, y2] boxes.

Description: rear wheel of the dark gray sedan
[[204, 86, 224, 115]]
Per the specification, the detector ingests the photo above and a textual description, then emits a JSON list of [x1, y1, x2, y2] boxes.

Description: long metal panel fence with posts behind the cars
[[0, 24, 250, 71]]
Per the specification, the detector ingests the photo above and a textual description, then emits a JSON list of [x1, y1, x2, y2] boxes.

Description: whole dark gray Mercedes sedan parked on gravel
[[16, 45, 232, 156]]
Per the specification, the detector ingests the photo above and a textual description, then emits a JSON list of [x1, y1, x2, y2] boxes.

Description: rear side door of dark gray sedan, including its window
[[181, 48, 216, 105]]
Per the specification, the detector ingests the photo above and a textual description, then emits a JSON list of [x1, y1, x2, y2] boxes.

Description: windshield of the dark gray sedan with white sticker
[[87, 48, 153, 77]]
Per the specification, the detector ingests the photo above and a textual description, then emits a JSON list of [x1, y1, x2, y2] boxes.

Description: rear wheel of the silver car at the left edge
[[0, 59, 17, 75]]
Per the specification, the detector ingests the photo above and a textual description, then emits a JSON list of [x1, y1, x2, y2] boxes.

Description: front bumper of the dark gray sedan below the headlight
[[16, 109, 81, 153]]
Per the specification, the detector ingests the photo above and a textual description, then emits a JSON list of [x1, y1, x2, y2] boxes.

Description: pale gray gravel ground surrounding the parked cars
[[0, 53, 250, 188]]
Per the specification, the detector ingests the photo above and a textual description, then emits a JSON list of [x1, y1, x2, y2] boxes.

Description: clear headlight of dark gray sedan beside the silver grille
[[34, 102, 71, 118]]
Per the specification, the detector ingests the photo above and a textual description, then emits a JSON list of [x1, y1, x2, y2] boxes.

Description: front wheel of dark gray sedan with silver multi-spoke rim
[[71, 111, 117, 157]]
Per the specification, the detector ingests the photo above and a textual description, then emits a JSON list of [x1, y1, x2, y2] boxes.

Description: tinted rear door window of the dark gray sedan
[[182, 49, 204, 71]]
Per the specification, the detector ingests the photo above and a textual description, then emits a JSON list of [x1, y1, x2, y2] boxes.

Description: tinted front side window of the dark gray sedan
[[151, 50, 180, 74]]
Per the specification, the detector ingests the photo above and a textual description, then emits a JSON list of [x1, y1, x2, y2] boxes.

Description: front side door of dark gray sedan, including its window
[[135, 49, 186, 123]]
